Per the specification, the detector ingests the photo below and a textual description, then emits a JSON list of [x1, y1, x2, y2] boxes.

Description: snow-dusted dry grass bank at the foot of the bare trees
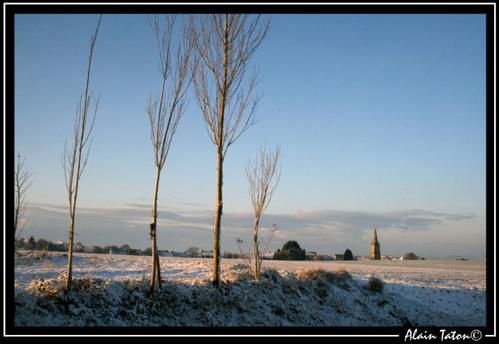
[[16, 266, 400, 326]]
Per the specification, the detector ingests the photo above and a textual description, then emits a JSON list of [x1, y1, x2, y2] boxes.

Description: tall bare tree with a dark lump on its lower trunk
[[146, 15, 192, 293]]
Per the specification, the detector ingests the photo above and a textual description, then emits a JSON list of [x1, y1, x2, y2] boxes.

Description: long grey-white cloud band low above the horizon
[[22, 203, 485, 256]]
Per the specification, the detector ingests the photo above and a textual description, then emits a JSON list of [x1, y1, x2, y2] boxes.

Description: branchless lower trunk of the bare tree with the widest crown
[[213, 150, 223, 288]]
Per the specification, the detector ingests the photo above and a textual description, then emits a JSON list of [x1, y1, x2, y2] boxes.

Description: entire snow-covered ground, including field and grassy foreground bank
[[15, 251, 486, 327]]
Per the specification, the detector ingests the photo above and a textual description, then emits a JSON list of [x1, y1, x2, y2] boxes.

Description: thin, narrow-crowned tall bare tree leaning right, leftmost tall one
[[62, 15, 102, 291]]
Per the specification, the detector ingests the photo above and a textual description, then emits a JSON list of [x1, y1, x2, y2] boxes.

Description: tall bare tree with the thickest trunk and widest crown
[[190, 14, 270, 287]]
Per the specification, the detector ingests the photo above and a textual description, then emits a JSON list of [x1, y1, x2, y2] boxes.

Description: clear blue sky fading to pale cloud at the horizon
[[14, 14, 486, 257]]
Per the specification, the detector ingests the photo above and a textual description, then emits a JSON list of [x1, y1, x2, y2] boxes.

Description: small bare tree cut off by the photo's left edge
[[14, 154, 32, 240]]
